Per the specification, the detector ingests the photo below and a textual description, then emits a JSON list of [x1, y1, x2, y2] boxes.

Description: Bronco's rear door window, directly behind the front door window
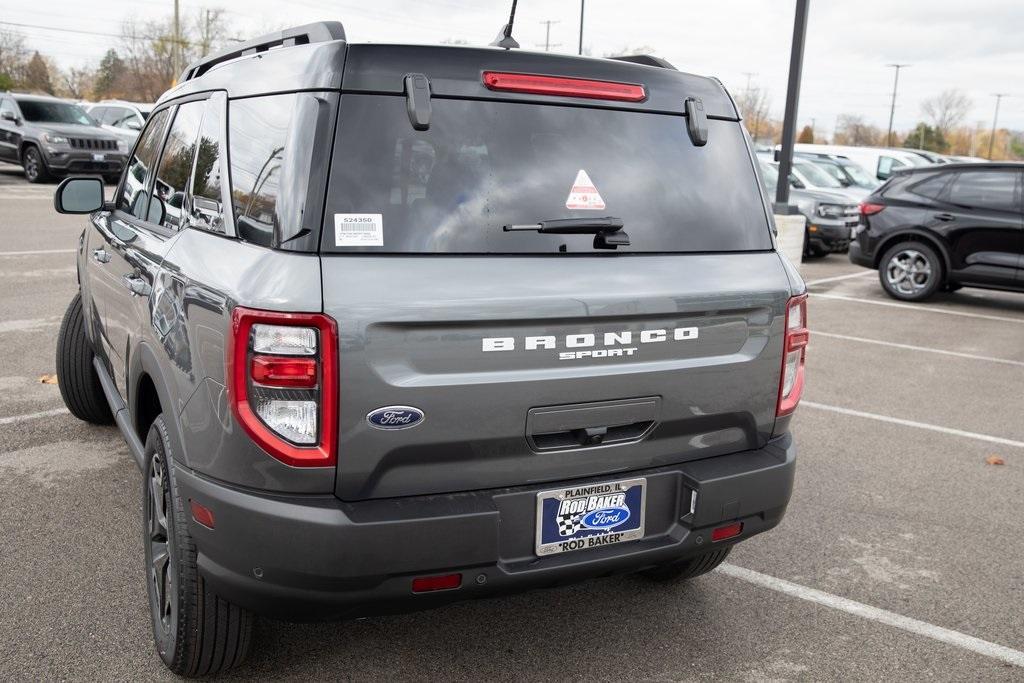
[[147, 100, 206, 230]]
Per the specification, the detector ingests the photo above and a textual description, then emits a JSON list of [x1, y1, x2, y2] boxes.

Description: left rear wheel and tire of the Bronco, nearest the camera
[[142, 415, 253, 678]]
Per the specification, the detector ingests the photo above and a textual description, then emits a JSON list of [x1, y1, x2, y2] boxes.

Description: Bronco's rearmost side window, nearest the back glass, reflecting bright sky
[[228, 94, 296, 247]]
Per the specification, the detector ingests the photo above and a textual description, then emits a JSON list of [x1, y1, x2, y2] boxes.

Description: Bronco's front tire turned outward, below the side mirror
[[56, 294, 114, 425]]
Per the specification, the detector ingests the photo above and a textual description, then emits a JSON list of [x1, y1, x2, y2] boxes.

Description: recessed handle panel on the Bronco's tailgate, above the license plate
[[526, 396, 662, 451]]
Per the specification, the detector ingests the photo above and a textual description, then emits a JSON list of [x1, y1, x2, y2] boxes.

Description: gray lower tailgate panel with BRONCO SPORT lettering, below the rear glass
[[324, 253, 788, 500]]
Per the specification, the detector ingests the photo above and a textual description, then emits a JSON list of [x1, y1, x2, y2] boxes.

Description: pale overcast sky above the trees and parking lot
[[0, 0, 1024, 135]]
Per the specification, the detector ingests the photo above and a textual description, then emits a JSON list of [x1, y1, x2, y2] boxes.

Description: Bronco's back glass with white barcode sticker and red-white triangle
[[323, 94, 771, 254]]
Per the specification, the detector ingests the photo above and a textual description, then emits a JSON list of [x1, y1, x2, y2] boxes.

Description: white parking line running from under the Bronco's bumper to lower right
[[717, 563, 1024, 667]]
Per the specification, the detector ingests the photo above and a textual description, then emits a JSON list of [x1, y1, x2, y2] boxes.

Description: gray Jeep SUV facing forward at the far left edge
[[0, 92, 128, 182]]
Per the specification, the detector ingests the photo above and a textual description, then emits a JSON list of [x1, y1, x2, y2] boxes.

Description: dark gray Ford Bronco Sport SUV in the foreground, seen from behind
[[55, 23, 808, 675]]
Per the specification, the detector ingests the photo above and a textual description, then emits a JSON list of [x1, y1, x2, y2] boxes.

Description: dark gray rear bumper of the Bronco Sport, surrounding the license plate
[[174, 434, 796, 621]]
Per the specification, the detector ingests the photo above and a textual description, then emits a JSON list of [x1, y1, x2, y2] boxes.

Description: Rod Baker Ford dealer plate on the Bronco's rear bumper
[[536, 478, 647, 555]]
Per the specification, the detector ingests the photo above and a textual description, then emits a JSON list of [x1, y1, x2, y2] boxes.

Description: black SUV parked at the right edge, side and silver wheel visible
[[850, 163, 1024, 301]]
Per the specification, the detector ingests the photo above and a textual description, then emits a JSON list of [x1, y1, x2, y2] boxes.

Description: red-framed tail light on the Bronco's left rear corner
[[227, 306, 338, 467]]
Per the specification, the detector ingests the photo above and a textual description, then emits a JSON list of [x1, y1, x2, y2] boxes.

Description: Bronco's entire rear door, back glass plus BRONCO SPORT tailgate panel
[[322, 93, 790, 500]]
